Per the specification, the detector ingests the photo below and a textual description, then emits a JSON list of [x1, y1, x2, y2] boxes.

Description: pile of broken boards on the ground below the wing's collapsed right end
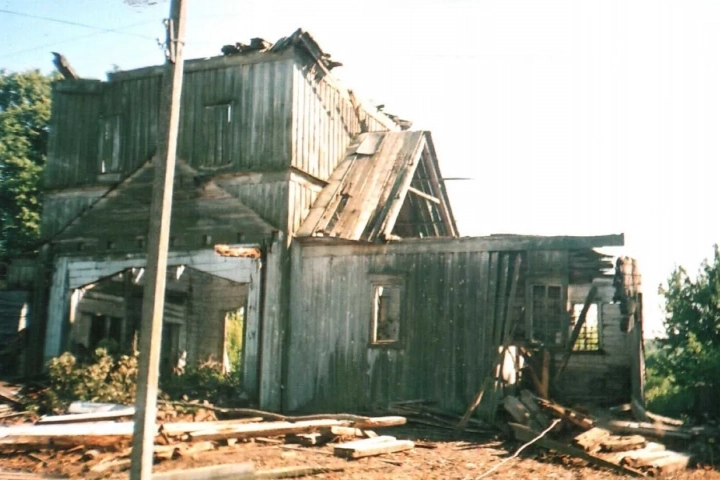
[[503, 390, 720, 477]]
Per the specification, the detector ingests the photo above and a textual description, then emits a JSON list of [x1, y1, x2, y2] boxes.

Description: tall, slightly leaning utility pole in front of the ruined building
[[130, 0, 187, 480]]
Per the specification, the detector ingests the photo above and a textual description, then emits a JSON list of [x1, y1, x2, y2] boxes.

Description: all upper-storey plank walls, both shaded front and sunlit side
[[42, 50, 397, 244]]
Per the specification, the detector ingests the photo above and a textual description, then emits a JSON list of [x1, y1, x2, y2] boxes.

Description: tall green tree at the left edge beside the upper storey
[[0, 70, 54, 258]]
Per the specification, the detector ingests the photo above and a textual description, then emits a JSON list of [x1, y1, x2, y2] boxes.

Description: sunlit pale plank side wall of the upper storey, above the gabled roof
[[292, 63, 389, 180]]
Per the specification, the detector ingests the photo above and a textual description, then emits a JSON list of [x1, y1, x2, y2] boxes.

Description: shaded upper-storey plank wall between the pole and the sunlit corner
[[178, 60, 293, 172]]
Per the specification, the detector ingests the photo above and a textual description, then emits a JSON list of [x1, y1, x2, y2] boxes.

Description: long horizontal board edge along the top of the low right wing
[[296, 233, 625, 255]]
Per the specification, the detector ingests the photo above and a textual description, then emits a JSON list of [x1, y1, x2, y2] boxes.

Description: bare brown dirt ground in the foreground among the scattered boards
[[0, 426, 720, 480]]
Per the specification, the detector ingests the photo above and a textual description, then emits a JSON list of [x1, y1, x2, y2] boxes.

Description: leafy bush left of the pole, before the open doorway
[[44, 348, 137, 410]]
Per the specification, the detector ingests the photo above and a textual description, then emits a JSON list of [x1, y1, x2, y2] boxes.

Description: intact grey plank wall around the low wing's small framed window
[[283, 247, 510, 411]]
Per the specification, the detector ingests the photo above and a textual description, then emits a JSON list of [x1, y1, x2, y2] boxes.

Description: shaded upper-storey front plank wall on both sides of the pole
[[46, 59, 293, 189]]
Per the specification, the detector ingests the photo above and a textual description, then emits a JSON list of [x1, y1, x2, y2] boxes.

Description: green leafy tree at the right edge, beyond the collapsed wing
[[657, 245, 720, 387]]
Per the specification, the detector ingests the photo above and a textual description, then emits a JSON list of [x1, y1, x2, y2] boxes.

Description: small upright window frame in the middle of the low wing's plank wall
[[370, 274, 405, 348]]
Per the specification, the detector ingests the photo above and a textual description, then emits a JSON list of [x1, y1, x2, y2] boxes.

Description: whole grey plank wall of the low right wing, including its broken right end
[[283, 237, 632, 412]]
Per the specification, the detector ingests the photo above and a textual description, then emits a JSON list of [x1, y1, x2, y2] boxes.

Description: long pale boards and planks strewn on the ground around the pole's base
[[0, 402, 415, 478]]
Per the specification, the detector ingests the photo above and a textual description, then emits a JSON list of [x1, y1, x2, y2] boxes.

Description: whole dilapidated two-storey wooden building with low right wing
[[29, 30, 642, 410]]
